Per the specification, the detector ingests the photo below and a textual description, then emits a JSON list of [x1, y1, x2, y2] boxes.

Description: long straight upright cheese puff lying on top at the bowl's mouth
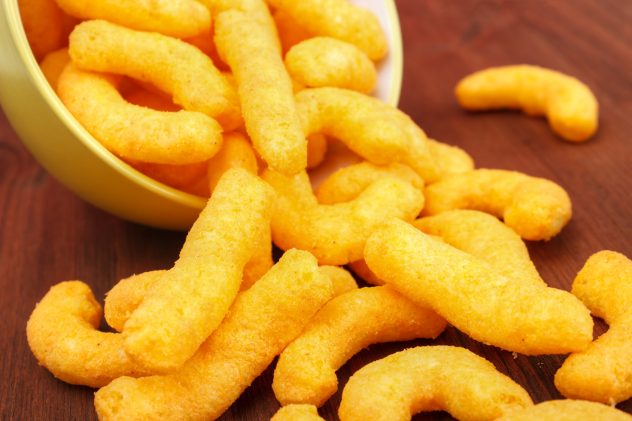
[[215, 10, 307, 175]]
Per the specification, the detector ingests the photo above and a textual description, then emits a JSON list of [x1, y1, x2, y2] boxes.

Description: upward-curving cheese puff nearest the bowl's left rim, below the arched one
[[57, 64, 222, 164]]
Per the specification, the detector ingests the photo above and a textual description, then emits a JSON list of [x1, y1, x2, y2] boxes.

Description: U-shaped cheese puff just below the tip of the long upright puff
[[263, 170, 423, 265]]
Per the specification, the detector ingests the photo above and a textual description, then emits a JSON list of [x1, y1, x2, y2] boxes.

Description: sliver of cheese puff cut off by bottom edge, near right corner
[[498, 399, 632, 421]]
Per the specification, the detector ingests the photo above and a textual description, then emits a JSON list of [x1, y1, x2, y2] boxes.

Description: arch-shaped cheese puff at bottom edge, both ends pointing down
[[338, 346, 533, 421]]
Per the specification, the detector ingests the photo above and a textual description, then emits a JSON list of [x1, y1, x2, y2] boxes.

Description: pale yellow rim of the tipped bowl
[[4, 0, 403, 209]]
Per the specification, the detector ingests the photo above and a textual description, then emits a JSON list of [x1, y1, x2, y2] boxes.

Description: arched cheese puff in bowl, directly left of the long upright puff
[[69, 20, 241, 130]]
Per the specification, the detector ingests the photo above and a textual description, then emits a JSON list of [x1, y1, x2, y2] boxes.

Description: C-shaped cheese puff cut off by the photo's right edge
[[555, 251, 632, 405]]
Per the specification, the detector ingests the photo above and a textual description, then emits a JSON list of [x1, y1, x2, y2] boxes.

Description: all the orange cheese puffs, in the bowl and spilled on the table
[[19, 0, 632, 421]]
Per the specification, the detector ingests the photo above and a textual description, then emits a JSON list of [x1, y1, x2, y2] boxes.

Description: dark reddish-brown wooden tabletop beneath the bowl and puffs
[[0, 0, 632, 420]]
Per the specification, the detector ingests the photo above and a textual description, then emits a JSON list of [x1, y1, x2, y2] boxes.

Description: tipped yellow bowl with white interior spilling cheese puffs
[[0, 0, 402, 230]]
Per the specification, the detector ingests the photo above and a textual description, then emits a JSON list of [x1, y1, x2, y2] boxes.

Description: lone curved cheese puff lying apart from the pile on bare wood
[[456, 65, 599, 142]]
